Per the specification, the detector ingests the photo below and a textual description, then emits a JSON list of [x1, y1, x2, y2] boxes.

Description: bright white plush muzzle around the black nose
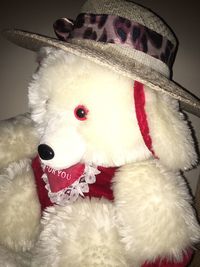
[[40, 115, 85, 169]]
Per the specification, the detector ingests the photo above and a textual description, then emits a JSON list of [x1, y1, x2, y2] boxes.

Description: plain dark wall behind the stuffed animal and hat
[[0, 0, 200, 191]]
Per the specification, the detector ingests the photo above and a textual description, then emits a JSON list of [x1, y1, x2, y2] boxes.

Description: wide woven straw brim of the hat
[[2, 29, 200, 117]]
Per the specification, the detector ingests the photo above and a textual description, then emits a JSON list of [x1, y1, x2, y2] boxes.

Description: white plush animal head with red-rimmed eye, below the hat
[[29, 48, 196, 172]]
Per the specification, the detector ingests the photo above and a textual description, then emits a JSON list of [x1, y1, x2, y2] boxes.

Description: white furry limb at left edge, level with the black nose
[[0, 114, 38, 168]]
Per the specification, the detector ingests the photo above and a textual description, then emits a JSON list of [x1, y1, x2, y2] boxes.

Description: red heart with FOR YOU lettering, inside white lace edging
[[44, 163, 85, 193]]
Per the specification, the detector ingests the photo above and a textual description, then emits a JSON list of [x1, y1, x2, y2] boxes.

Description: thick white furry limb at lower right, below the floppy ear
[[113, 160, 200, 263]]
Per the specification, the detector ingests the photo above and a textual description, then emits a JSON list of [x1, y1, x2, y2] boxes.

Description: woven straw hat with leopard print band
[[2, 0, 200, 117]]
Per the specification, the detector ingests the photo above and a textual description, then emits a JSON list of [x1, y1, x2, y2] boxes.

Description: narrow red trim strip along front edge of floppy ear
[[134, 81, 155, 157]]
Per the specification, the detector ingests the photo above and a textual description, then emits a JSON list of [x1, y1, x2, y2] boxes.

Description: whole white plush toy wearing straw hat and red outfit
[[0, 0, 200, 267]]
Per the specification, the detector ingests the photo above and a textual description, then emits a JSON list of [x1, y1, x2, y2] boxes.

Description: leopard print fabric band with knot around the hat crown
[[54, 13, 176, 74]]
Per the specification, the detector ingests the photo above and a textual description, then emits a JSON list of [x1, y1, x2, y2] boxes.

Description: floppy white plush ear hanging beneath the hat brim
[[145, 87, 197, 170]]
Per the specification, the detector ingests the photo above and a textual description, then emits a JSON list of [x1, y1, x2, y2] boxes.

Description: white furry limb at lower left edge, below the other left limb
[[0, 160, 40, 251]]
